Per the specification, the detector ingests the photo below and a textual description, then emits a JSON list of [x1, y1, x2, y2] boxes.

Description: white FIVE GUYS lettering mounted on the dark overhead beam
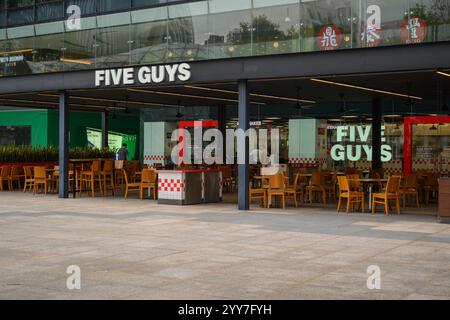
[[95, 63, 191, 87]]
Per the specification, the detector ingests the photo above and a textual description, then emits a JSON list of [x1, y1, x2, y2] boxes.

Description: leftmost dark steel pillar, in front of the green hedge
[[59, 91, 69, 199]]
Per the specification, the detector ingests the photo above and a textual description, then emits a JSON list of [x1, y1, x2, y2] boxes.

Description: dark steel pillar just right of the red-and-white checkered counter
[[237, 80, 250, 210]]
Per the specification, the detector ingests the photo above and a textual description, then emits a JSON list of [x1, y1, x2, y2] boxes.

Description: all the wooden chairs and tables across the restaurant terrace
[[0, 159, 439, 215]]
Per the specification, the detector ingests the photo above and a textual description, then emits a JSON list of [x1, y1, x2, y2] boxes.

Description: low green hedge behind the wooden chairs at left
[[0, 146, 115, 163]]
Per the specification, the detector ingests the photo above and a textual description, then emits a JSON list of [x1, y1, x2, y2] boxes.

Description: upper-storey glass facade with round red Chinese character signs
[[0, 0, 450, 76]]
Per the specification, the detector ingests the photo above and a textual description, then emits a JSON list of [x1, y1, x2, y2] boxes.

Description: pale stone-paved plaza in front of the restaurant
[[0, 192, 450, 299]]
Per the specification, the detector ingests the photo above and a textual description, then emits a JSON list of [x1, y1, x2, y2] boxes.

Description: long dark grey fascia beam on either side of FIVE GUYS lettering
[[0, 42, 450, 94]]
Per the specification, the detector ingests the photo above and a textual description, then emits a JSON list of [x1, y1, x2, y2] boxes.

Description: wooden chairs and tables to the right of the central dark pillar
[[250, 168, 440, 215]]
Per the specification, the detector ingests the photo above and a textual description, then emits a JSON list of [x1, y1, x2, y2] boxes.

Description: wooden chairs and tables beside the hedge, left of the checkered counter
[[0, 159, 157, 199]]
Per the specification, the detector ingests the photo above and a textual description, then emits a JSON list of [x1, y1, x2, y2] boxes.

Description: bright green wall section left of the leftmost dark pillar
[[0, 110, 49, 147]]
